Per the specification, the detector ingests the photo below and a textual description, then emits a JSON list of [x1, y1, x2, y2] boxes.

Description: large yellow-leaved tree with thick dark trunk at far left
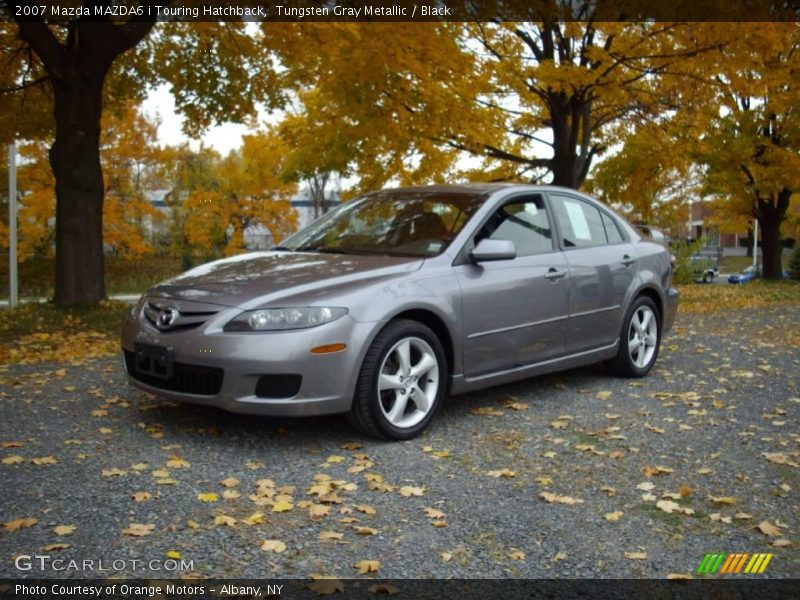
[[0, 9, 284, 304]]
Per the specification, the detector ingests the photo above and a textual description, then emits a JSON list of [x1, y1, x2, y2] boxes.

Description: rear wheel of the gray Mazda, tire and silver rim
[[608, 296, 661, 377]]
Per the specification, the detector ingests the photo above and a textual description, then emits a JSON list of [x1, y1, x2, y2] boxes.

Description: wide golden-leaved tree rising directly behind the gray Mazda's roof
[[270, 15, 724, 188]]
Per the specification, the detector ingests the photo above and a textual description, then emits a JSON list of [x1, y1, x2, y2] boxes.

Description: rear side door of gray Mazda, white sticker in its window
[[548, 192, 638, 354]]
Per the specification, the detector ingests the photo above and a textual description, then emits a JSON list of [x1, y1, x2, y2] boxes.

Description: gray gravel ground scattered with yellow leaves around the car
[[0, 305, 800, 578]]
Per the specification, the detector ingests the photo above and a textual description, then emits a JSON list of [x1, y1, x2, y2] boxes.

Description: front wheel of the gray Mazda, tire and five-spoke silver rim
[[349, 320, 448, 440]]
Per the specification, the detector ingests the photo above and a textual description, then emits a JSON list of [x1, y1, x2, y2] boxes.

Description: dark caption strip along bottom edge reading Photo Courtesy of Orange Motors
[[0, 579, 800, 600]]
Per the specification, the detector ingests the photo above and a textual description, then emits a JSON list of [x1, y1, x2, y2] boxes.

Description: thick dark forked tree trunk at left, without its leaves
[[12, 16, 155, 305]]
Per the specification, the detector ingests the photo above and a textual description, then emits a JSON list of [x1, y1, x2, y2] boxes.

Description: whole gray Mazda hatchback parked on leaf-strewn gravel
[[122, 185, 678, 439]]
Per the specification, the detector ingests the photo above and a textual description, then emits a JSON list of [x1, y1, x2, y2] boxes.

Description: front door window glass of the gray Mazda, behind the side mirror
[[475, 196, 553, 256]]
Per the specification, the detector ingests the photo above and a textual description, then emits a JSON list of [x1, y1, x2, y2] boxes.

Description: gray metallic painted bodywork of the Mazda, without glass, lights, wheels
[[122, 185, 678, 416]]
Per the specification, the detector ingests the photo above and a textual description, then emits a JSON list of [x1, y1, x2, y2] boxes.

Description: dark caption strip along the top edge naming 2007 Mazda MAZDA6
[[0, 0, 800, 23]]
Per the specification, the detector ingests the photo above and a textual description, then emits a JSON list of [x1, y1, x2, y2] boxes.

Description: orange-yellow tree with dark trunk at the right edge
[[700, 23, 800, 279]]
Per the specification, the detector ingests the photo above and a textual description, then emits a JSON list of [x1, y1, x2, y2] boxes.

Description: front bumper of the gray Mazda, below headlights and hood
[[122, 310, 376, 416]]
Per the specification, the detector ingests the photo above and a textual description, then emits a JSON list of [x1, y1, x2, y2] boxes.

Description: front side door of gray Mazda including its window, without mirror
[[455, 194, 569, 377]]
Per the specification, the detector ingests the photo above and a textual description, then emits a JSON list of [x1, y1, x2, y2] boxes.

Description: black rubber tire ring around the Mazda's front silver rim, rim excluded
[[362, 321, 448, 440]]
